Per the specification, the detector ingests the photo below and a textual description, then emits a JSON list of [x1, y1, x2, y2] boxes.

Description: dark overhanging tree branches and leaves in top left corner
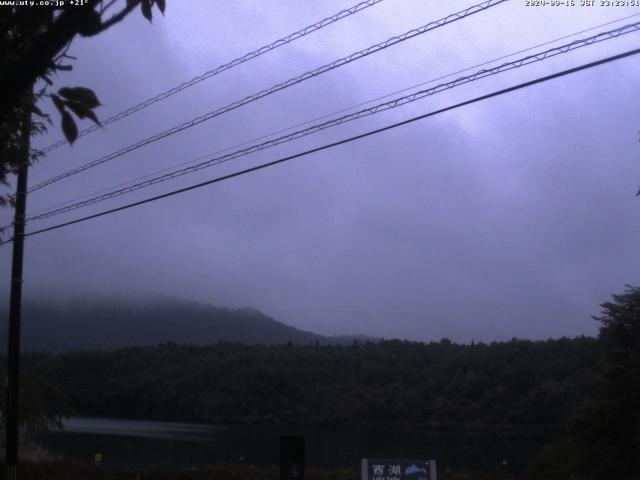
[[0, 0, 166, 214]]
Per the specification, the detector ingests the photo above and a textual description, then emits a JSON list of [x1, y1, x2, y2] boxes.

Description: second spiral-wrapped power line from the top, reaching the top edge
[[29, 0, 508, 193]]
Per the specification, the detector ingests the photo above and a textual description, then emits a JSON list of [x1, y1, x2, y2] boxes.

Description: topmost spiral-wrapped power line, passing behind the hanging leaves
[[42, 0, 390, 153]]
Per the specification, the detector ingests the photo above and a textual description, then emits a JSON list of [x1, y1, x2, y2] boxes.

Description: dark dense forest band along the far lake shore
[[11, 337, 600, 430]]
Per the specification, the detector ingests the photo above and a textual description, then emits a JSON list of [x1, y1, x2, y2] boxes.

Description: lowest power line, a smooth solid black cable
[[0, 48, 640, 245]]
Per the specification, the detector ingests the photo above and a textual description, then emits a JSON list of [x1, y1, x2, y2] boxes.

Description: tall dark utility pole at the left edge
[[5, 97, 31, 480]]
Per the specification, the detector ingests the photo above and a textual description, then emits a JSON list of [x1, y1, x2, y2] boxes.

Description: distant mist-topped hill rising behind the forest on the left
[[0, 297, 376, 352]]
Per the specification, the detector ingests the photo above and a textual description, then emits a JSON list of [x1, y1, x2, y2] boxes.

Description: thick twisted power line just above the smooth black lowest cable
[[27, 22, 640, 221]]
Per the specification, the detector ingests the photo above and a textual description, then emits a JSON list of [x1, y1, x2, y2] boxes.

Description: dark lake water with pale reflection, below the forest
[[38, 417, 551, 473]]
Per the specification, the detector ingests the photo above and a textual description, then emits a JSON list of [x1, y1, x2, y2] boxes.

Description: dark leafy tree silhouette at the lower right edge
[[529, 286, 640, 480]]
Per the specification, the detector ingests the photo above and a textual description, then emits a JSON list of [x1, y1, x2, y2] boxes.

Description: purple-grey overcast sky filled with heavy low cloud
[[0, 0, 640, 342]]
